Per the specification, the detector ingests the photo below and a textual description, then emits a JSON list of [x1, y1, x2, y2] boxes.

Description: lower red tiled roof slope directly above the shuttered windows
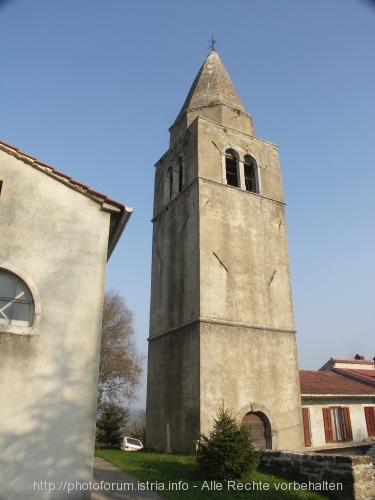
[[299, 370, 375, 397]]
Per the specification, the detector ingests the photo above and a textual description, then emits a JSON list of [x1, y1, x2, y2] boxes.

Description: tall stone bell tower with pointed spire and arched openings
[[146, 51, 304, 452]]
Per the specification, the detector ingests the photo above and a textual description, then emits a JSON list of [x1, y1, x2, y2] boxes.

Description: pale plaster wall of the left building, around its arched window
[[0, 151, 109, 500]]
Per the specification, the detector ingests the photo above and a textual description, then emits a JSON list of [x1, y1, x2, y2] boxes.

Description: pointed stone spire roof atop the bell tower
[[176, 51, 245, 121]]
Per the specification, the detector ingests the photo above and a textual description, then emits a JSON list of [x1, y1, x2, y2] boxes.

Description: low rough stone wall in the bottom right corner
[[261, 450, 375, 500]]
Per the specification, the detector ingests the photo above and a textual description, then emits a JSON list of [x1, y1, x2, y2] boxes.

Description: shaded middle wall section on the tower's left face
[[150, 169, 203, 337]]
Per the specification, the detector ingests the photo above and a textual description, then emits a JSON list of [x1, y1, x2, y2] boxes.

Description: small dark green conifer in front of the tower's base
[[196, 408, 260, 479]]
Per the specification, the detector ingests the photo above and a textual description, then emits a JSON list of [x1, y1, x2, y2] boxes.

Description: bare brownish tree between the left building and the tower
[[99, 290, 144, 403]]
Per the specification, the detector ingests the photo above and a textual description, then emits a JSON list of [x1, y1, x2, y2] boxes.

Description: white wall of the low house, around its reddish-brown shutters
[[302, 398, 375, 446]]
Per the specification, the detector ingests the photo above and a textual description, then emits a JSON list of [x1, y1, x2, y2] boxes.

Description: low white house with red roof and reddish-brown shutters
[[300, 355, 375, 449]]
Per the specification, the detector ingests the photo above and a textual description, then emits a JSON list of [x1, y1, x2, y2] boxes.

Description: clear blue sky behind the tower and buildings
[[0, 0, 375, 407]]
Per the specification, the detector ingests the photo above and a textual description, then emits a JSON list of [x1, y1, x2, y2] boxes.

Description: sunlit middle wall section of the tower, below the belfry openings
[[199, 180, 294, 328]]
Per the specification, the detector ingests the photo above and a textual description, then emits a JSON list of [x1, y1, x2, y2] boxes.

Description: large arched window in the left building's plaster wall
[[0, 269, 34, 326]]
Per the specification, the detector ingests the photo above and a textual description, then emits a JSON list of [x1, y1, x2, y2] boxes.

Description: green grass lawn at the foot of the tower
[[95, 450, 327, 500]]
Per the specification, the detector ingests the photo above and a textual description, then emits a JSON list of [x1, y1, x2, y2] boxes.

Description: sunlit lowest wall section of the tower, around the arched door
[[200, 322, 303, 450]]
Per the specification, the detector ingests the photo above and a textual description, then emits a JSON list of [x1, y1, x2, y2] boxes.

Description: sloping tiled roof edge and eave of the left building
[[0, 140, 133, 259]]
